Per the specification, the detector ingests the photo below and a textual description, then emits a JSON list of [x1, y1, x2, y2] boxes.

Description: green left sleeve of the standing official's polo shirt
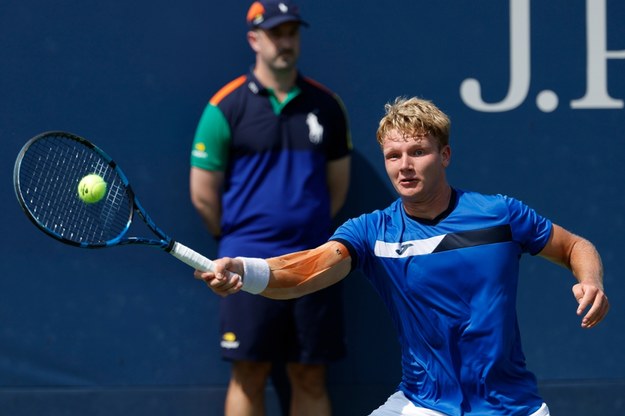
[[191, 104, 231, 171]]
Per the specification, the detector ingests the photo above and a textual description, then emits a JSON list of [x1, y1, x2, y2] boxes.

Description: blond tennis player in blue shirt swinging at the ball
[[195, 98, 609, 416]]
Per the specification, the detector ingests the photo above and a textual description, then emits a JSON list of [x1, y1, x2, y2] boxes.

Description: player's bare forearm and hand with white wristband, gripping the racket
[[194, 241, 351, 299]]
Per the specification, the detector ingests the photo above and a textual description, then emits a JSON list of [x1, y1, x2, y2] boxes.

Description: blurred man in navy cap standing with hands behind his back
[[190, 0, 351, 416]]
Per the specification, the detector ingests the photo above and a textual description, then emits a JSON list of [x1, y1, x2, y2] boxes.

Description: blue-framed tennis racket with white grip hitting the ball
[[13, 131, 213, 271]]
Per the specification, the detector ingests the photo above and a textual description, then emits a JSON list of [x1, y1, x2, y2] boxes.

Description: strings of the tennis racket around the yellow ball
[[18, 135, 132, 245]]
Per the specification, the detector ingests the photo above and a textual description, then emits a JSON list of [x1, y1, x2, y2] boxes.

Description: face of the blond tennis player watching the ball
[[382, 130, 451, 204]]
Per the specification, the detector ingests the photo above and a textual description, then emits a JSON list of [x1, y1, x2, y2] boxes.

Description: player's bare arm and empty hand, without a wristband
[[540, 224, 610, 328]]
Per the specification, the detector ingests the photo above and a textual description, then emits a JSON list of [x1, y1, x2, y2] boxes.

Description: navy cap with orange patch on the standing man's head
[[246, 0, 308, 29]]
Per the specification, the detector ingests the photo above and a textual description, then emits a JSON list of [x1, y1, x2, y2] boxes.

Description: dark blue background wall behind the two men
[[0, 0, 625, 415]]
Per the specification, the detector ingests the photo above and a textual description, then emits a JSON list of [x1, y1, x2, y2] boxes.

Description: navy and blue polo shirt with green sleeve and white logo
[[191, 72, 351, 257]]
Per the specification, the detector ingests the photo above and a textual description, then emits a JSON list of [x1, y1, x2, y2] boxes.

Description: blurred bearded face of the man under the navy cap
[[250, 22, 300, 71]]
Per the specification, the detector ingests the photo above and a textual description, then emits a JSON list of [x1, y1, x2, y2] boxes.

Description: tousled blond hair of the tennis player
[[376, 97, 451, 148]]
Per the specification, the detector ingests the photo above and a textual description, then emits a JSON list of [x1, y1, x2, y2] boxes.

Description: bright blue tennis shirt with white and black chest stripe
[[331, 190, 552, 416]]
